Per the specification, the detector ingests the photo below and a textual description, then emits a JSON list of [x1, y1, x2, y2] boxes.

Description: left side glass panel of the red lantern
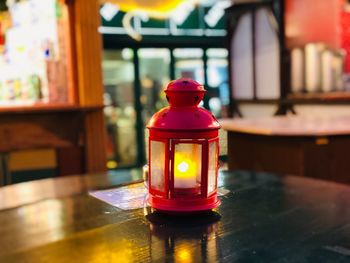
[[150, 141, 165, 192]]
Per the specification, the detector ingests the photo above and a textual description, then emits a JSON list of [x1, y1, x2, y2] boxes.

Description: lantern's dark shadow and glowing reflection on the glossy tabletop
[[146, 211, 222, 262]]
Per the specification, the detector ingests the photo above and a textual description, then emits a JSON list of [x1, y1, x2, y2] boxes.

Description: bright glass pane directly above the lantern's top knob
[[174, 48, 204, 84]]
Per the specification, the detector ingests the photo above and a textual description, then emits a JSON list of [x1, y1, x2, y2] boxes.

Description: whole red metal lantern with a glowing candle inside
[[147, 79, 220, 213]]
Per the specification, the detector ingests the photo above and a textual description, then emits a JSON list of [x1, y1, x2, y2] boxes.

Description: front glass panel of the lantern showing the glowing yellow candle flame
[[173, 143, 202, 191]]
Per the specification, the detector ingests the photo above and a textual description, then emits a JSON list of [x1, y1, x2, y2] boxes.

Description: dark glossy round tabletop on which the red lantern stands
[[0, 170, 350, 263]]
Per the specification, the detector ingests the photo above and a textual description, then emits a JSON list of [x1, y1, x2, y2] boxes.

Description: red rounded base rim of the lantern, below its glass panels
[[148, 194, 221, 214]]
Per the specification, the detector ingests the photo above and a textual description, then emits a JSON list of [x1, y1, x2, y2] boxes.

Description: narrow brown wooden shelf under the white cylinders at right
[[287, 91, 350, 104]]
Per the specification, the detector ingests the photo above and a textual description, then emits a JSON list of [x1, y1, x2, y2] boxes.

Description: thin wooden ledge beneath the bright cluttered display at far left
[[0, 103, 104, 115]]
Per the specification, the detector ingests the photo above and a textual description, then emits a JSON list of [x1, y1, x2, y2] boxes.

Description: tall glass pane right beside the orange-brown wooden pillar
[[102, 48, 137, 169]]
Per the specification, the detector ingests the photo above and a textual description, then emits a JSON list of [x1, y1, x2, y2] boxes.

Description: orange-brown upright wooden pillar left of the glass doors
[[73, 0, 107, 173]]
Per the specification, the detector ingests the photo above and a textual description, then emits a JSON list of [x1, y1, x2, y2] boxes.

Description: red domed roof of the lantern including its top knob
[[147, 79, 221, 131]]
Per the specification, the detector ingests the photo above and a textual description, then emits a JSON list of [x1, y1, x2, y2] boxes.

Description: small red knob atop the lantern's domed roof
[[164, 78, 205, 107]]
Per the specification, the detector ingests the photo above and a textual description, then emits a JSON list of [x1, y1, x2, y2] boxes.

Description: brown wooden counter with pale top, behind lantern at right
[[220, 116, 350, 183]]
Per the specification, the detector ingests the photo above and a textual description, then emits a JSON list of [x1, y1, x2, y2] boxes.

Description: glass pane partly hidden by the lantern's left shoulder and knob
[[138, 48, 170, 124]]
